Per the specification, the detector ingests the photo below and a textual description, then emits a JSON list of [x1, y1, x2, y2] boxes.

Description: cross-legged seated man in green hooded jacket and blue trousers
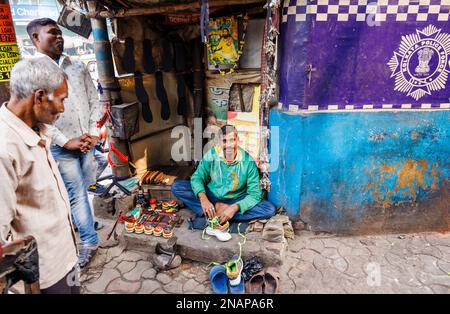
[[172, 125, 275, 223]]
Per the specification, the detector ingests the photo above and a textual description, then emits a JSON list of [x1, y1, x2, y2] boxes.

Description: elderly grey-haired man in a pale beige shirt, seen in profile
[[0, 58, 80, 294]]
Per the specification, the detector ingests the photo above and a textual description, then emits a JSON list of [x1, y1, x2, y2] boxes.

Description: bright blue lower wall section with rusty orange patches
[[269, 110, 450, 233]]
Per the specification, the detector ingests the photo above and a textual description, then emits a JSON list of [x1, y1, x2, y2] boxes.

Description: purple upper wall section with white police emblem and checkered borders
[[280, 0, 450, 111]]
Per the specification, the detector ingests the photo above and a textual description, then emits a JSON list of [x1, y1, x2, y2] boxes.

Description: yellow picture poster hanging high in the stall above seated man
[[208, 16, 239, 70]]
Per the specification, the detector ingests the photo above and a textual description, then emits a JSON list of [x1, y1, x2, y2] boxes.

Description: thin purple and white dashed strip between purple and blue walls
[[278, 103, 450, 112]]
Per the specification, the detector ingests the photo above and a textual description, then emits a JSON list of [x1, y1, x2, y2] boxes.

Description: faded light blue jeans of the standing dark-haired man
[[51, 145, 98, 246]]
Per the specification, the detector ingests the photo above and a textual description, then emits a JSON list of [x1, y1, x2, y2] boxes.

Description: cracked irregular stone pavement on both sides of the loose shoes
[[81, 220, 450, 294]]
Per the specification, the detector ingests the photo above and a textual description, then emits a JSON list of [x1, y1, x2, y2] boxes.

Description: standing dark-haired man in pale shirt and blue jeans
[[27, 18, 101, 268]]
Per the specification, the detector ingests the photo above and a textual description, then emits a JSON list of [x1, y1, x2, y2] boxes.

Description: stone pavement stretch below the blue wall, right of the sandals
[[281, 232, 450, 293]]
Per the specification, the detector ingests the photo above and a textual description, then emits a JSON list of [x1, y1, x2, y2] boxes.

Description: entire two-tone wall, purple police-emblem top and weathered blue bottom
[[269, 0, 450, 233]]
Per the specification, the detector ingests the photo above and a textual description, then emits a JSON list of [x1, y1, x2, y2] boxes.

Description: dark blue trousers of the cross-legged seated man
[[171, 180, 276, 221]]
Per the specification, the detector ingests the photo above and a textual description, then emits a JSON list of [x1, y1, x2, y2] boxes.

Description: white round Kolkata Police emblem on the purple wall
[[388, 25, 450, 100]]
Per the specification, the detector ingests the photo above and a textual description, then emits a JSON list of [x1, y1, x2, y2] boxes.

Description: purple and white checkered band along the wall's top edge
[[282, 0, 450, 23]]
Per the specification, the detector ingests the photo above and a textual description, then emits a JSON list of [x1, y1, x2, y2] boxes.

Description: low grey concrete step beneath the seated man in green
[[119, 210, 287, 266]]
